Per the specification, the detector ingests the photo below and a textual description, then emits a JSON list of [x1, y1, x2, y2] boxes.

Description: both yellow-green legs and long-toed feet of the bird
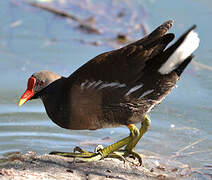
[[50, 116, 151, 164]]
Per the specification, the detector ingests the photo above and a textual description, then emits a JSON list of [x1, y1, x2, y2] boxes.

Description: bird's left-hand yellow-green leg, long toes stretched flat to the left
[[50, 124, 139, 162]]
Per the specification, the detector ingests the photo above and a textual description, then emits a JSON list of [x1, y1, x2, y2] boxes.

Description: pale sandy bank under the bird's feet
[[0, 152, 197, 180]]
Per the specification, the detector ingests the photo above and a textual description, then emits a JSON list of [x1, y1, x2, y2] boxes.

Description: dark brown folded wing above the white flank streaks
[[69, 21, 174, 85]]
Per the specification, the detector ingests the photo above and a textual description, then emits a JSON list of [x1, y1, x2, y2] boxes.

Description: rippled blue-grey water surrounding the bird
[[0, 0, 212, 177]]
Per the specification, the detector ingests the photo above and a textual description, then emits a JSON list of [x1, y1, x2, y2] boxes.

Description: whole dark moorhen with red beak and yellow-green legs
[[18, 20, 200, 164]]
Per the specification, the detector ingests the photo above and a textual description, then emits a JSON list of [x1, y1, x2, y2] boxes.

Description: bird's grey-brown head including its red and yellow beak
[[18, 71, 61, 106]]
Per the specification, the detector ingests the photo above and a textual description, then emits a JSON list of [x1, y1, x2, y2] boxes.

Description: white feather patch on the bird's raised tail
[[158, 31, 200, 74]]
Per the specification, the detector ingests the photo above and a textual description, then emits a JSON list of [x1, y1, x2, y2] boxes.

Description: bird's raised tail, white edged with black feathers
[[158, 25, 200, 76]]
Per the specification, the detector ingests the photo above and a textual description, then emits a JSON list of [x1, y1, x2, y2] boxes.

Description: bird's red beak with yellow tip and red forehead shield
[[18, 77, 36, 106]]
